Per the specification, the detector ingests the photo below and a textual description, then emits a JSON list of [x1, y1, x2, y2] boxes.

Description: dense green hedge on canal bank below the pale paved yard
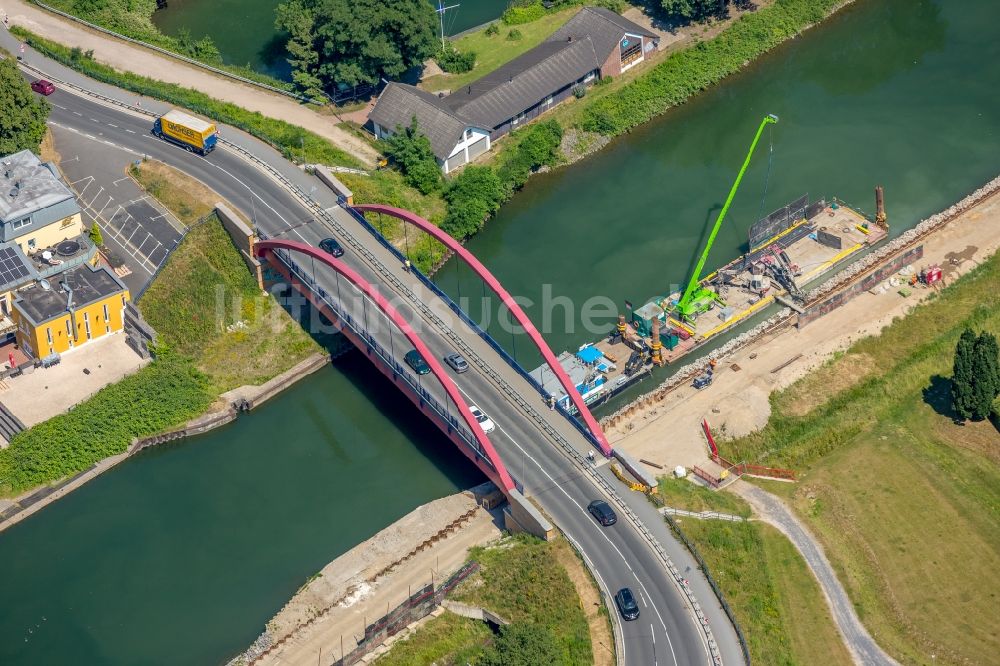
[[0, 350, 213, 495]]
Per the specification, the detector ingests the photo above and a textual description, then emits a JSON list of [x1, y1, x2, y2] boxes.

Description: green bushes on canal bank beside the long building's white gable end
[[441, 120, 562, 240]]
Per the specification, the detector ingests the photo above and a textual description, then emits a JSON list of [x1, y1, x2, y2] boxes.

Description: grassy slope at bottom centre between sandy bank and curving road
[[375, 536, 592, 666]]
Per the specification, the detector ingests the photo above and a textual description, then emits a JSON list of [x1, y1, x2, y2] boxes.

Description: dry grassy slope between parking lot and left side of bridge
[[139, 217, 321, 392]]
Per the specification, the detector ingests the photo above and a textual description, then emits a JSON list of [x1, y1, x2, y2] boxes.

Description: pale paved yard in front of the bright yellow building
[[0, 334, 148, 426]]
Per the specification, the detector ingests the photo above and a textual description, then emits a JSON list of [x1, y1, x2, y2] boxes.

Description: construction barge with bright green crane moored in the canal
[[531, 115, 889, 410]]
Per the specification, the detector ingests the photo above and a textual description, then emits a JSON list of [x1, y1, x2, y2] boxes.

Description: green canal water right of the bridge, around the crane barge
[[435, 0, 1000, 370]]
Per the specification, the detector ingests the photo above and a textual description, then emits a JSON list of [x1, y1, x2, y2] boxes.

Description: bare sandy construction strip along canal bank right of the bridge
[[606, 189, 1000, 469]]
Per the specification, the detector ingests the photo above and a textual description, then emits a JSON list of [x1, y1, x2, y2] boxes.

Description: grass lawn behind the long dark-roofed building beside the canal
[[420, 7, 580, 92]]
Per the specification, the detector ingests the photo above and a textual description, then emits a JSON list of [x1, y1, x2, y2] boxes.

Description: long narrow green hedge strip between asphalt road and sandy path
[[10, 26, 362, 167]]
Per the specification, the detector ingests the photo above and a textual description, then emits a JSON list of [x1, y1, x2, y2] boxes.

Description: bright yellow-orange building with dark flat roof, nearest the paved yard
[[13, 265, 129, 358]]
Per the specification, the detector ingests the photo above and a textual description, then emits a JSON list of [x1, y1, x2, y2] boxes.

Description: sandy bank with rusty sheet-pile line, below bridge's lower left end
[[241, 492, 501, 666]]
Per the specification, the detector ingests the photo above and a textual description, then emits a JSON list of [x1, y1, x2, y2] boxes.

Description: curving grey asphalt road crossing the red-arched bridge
[[37, 75, 742, 666]]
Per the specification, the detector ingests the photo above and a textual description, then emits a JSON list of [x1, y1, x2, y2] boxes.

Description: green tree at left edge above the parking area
[[0, 58, 50, 155]]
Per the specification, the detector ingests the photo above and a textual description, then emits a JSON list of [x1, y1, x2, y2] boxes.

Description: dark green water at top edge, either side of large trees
[[153, 0, 508, 79]]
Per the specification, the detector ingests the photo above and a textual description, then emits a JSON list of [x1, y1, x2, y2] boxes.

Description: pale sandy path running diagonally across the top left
[[3, 0, 377, 164]]
